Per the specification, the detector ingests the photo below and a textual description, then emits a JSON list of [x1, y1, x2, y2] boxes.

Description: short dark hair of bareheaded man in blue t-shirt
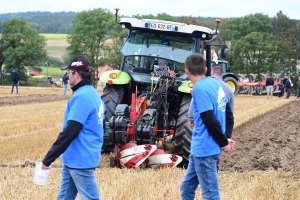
[[184, 53, 206, 75]]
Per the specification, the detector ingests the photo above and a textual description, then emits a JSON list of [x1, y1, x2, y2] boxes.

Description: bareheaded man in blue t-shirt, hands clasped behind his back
[[180, 53, 235, 200]]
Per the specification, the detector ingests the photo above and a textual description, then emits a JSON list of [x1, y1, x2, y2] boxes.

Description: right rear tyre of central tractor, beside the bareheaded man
[[174, 94, 192, 167]]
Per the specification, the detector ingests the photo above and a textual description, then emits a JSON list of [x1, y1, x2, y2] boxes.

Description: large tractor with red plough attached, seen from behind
[[100, 9, 220, 168]]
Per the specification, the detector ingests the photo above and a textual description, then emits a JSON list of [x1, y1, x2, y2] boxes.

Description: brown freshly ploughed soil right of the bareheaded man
[[219, 101, 300, 174]]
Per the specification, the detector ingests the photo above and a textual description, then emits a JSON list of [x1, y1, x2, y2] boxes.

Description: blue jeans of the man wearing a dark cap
[[56, 165, 100, 200]]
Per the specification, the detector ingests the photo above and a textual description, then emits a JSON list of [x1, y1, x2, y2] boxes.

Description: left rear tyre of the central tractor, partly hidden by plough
[[101, 85, 124, 122]]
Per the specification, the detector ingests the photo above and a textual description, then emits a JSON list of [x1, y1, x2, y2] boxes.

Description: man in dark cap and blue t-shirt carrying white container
[[42, 56, 105, 199]]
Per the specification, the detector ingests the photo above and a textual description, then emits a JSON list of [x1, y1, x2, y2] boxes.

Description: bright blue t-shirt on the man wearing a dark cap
[[62, 85, 105, 169]]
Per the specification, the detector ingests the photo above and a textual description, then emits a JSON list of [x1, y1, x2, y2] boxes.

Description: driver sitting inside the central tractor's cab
[[154, 39, 176, 78]]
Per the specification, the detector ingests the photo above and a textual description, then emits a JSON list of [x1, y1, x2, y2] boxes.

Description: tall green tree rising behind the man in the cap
[[67, 8, 114, 87]]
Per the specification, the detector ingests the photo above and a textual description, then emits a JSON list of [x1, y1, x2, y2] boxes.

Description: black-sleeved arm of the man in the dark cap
[[42, 120, 83, 167]]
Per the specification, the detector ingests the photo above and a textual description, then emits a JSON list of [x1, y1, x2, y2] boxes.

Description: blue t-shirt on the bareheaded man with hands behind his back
[[191, 77, 228, 157]]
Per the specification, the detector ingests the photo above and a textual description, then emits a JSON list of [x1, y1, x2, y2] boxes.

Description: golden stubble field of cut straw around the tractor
[[0, 87, 300, 200]]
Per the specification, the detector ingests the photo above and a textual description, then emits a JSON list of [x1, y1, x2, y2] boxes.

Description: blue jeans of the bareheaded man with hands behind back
[[180, 154, 221, 200]]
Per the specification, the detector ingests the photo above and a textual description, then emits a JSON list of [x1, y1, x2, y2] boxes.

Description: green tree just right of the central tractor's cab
[[224, 13, 278, 79]]
